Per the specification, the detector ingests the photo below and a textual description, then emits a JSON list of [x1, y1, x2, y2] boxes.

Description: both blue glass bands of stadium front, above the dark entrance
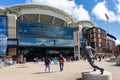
[[17, 21, 75, 47]]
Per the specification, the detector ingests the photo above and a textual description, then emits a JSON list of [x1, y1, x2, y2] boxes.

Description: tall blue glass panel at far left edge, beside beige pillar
[[0, 16, 7, 55]]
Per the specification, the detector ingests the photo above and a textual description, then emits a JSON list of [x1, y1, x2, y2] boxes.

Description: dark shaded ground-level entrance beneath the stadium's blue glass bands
[[18, 47, 74, 61]]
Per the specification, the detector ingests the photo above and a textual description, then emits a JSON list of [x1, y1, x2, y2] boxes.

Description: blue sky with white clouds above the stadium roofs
[[0, 0, 120, 44]]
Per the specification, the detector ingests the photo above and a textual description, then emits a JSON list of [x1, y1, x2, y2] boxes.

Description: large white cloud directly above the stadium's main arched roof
[[26, 0, 90, 20]]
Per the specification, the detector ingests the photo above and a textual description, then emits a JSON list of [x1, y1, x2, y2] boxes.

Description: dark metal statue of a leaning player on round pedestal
[[81, 43, 104, 74]]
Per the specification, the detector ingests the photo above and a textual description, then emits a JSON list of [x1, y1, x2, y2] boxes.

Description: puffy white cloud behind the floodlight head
[[92, 1, 117, 22]]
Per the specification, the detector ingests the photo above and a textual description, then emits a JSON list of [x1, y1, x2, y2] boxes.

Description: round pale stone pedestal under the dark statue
[[81, 70, 112, 80]]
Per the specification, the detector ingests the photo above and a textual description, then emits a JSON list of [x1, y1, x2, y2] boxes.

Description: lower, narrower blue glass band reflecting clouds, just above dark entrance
[[19, 37, 74, 46]]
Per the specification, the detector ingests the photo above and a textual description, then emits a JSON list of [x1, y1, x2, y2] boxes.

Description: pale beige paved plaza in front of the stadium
[[0, 60, 120, 80]]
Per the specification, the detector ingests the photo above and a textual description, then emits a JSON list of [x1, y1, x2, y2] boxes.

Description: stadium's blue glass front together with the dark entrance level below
[[17, 20, 75, 61]]
